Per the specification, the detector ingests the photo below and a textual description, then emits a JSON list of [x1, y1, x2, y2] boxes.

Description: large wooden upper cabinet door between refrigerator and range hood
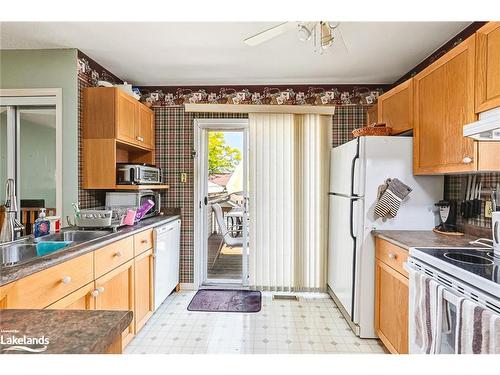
[[413, 35, 477, 174]]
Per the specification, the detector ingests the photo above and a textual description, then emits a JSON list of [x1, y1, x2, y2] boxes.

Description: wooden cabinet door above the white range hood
[[476, 22, 500, 113]]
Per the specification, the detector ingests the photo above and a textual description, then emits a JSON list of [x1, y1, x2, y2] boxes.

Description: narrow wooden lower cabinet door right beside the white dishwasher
[[134, 249, 154, 333]]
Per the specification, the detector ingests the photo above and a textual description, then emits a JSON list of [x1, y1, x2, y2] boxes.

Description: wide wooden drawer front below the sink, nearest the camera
[[0, 253, 94, 309]]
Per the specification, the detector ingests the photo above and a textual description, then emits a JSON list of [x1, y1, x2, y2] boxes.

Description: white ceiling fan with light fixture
[[243, 21, 348, 54]]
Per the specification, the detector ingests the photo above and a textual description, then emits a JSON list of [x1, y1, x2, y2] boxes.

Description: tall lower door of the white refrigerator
[[328, 195, 360, 320]]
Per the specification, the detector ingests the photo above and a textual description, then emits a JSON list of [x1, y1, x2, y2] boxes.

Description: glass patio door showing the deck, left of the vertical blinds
[[195, 119, 249, 286]]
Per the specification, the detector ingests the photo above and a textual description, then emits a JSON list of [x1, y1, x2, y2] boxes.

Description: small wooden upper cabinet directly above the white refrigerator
[[377, 78, 413, 134]]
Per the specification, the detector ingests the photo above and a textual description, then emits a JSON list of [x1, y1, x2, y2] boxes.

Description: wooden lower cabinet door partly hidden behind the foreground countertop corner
[[95, 260, 135, 348]]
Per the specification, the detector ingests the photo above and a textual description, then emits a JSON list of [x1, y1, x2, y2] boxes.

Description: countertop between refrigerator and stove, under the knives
[[372, 230, 481, 250]]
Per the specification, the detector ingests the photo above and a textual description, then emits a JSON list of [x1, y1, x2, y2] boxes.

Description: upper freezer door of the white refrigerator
[[330, 140, 363, 196]]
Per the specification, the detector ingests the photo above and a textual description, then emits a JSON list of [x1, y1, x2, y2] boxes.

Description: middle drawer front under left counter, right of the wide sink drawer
[[94, 236, 134, 278]]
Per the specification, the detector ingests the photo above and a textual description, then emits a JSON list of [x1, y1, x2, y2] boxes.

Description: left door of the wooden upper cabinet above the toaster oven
[[115, 89, 139, 143]]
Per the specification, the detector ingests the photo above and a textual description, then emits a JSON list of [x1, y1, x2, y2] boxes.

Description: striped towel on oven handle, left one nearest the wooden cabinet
[[409, 268, 444, 354]]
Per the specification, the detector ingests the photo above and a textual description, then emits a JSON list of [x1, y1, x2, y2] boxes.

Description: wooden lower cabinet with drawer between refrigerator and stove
[[375, 239, 409, 354]]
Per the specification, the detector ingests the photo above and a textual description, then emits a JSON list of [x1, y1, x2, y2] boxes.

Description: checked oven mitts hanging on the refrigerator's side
[[375, 178, 412, 218]]
